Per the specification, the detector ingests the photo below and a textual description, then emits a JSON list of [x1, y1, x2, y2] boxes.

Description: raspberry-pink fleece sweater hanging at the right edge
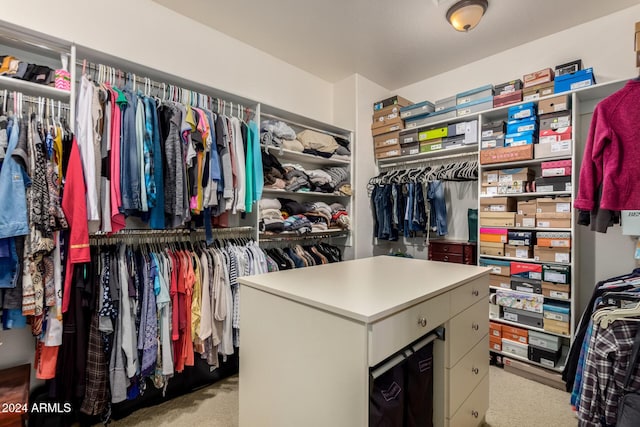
[[574, 79, 640, 211]]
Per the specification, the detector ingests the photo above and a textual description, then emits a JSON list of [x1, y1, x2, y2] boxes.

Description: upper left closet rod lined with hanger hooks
[[76, 60, 255, 116]]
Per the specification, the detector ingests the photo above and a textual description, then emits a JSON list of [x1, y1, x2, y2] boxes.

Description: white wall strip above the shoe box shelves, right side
[[392, 5, 640, 102]]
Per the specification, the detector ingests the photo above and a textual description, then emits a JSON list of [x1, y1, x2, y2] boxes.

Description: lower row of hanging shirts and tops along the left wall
[[35, 239, 268, 415]]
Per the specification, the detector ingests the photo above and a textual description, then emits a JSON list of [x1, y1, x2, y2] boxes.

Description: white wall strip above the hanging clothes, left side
[[0, 0, 333, 122]]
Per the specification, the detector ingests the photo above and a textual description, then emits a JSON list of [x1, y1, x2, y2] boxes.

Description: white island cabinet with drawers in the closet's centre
[[239, 256, 489, 427]]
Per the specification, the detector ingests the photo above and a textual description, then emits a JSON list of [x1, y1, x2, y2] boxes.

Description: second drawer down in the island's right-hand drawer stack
[[447, 298, 489, 368]]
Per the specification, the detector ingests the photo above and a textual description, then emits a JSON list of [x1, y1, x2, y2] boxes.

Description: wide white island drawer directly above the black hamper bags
[[369, 293, 450, 366]]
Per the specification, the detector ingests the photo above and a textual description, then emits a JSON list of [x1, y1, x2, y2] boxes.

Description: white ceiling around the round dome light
[[154, 0, 640, 89]]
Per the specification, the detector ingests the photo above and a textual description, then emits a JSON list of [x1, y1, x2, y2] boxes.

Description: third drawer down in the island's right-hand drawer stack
[[449, 335, 489, 415]]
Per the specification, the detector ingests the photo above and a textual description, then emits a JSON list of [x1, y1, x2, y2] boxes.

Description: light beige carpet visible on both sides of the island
[[104, 367, 578, 427]]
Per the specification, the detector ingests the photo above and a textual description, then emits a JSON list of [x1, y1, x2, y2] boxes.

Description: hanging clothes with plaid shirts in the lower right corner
[[562, 269, 640, 427]]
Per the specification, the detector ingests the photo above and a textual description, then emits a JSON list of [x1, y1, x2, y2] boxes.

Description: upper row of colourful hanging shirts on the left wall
[[76, 61, 263, 233]]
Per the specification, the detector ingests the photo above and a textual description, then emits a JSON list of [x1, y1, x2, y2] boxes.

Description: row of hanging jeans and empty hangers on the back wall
[[368, 161, 478, 241]]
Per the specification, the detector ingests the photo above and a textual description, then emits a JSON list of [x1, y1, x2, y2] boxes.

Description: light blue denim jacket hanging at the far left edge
[[0, 118, 31, 238]]
